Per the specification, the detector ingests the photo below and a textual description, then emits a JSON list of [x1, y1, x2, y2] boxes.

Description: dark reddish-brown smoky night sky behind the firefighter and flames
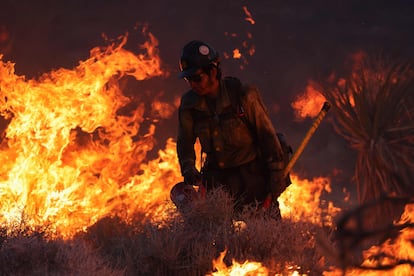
[[0, 0, 414, 205]]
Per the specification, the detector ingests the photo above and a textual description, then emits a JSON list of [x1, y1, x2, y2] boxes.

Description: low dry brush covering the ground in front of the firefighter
[[0, 187, 326, 275]]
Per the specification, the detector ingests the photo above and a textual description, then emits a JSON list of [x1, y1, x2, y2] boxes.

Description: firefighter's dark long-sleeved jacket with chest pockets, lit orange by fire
[[177, 78, 285, 196]]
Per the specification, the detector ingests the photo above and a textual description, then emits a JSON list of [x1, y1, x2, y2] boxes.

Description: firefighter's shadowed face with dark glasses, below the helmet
[[185, 68, 219, 96]]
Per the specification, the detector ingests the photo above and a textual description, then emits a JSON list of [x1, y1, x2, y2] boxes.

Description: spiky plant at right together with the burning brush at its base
[[322, 53, 414, 275]]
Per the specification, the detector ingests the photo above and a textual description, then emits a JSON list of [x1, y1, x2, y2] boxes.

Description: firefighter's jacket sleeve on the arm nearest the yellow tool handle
[[242, 87, 285, 171]]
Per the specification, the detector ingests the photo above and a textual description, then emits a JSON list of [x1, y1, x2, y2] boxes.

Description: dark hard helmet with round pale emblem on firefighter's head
[[179, 40, 219, 78]]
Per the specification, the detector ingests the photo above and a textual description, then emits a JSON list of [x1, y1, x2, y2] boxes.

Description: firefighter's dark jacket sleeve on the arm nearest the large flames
[[177, 94, 196, 175]]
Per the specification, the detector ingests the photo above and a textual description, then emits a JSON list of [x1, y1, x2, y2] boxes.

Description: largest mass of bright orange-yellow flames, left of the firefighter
[[0, 34, 178, 237]]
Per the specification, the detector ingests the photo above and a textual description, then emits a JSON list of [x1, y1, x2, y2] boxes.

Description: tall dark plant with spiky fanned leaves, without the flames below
[[323, 55, 414, 229]]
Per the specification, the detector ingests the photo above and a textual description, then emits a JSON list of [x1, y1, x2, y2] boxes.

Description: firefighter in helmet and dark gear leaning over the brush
[[177, 40, 286, 216]]
